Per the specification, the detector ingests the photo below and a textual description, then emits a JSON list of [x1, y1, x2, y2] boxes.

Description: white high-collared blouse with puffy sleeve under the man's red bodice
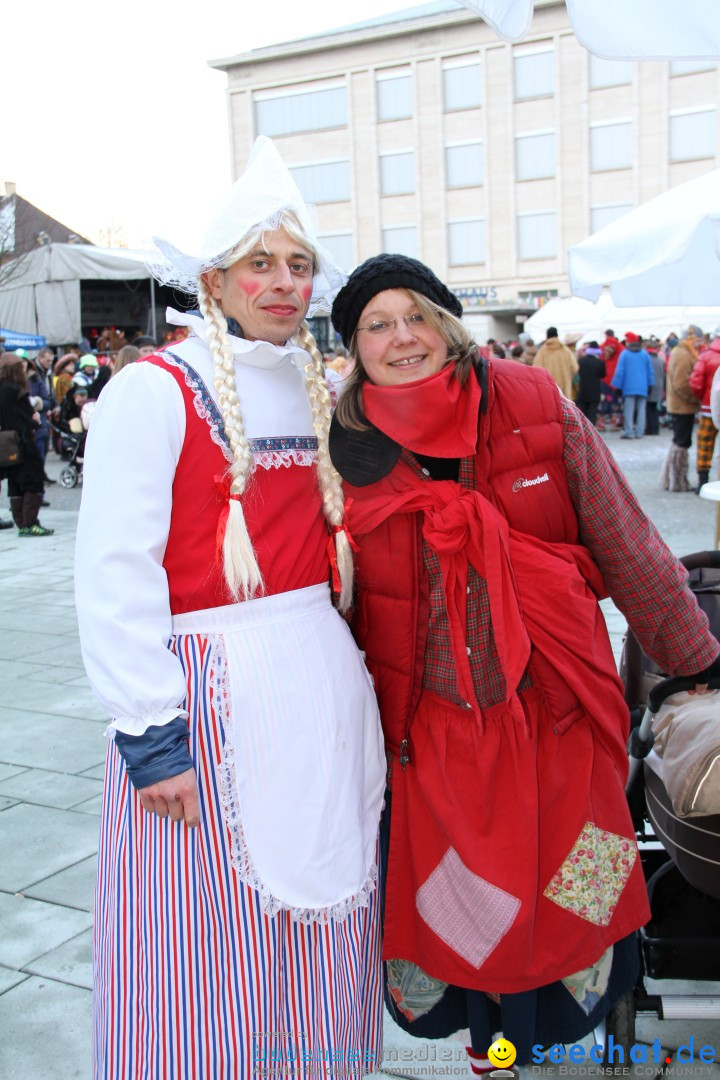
[[76, 314, 313, 735]]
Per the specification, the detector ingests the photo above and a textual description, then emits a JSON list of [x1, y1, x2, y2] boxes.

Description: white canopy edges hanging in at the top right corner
[[459, 0, 720, 59]]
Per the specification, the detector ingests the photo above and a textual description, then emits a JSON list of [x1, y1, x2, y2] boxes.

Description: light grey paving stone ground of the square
[[0, 431, 720, 1080]]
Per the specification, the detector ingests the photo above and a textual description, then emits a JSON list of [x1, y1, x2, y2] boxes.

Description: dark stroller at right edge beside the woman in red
[[604, 551, 720, 1053]]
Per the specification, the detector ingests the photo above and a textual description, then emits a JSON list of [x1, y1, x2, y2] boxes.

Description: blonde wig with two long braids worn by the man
[[198, 211, 353, 611]]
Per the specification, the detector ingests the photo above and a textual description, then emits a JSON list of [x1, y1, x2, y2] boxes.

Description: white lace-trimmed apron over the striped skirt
[[173, 584, 385, 921]]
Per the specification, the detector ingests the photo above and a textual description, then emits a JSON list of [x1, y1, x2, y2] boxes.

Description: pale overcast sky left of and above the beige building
[[0, 0, 412, 246]]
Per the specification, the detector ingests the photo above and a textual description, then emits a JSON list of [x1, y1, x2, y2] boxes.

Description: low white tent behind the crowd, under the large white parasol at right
[[524, 293, 720, 341]]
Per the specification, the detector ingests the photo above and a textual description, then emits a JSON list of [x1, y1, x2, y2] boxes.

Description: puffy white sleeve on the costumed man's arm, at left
[[76, 363, 187, 735]]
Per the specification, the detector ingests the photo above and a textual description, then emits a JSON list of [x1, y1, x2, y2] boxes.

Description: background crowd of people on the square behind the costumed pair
[[0, 317, 720, 537]]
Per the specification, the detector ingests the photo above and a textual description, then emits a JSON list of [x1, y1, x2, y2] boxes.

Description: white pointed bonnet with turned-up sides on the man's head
[[150, 135, 345, 315]]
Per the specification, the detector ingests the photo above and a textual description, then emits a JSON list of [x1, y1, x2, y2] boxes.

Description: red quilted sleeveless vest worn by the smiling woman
[[345, 360, 579, 750]]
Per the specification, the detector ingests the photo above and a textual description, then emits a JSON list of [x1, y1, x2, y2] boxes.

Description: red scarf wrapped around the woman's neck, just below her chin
[[363, 363, 480, 458]]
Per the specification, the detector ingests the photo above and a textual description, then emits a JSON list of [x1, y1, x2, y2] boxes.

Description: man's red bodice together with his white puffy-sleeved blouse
[[77, 315, 330, 734]]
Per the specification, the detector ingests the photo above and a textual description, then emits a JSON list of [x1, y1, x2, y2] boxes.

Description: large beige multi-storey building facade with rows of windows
[[212, 0, 720, 338]]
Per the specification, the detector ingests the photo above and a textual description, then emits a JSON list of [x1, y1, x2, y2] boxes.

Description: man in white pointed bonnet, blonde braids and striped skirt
[[77, 138, 384, 1080]]
